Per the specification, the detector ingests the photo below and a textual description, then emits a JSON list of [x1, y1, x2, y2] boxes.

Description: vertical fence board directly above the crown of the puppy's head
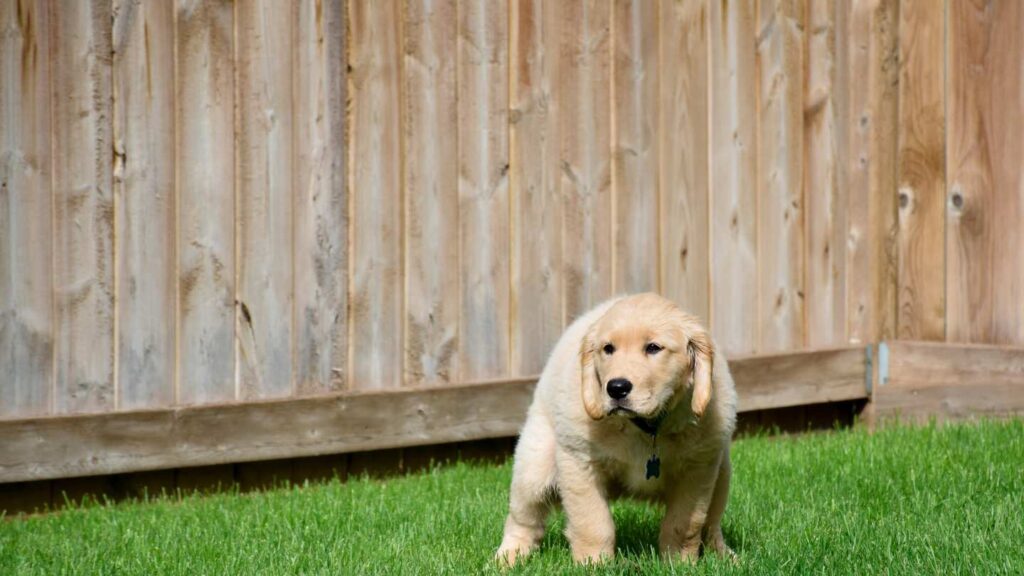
[[611, 0, 659, 292]]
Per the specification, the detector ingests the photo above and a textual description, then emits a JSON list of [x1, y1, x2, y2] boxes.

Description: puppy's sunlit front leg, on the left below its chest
[[556, 450, 615, 563]]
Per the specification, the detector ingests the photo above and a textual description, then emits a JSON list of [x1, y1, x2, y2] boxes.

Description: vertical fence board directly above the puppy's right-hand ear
[[657, 0, 711, 320]]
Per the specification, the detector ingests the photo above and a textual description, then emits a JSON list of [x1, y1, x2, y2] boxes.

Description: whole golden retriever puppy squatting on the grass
[[497, 293, 736, 565]]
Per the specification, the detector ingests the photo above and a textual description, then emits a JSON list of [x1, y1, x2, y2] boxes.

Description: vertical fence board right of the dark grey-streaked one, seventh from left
[[348, 0, 404, 388]]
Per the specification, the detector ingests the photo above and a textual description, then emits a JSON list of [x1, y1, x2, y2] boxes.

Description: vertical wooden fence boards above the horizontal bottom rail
[[0, 0, 1024, 480]]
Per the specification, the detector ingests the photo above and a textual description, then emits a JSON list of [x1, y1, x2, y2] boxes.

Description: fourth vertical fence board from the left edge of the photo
[[175, 0, 236, 404]]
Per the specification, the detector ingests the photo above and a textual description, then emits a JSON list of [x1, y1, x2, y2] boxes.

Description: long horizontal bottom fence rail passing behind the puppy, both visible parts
[[0, 346, 866, 486]]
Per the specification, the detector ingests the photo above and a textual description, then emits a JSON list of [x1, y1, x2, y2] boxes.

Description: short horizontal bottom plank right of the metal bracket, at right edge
[[871, 341, 1024, 422]]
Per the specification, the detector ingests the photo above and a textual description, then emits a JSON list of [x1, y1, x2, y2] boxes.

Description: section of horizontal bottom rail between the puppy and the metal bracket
[[729, 346, 867, 412]]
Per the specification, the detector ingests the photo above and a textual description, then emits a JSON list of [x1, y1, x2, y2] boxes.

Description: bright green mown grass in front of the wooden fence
[[0, 420, 1024, 575]]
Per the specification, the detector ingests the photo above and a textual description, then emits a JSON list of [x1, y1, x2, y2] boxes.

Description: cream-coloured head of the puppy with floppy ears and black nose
[[581, 294, 714, 420]]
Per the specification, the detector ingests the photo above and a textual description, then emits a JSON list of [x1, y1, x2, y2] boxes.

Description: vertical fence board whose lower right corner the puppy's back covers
[[509, 0, 563, 374]]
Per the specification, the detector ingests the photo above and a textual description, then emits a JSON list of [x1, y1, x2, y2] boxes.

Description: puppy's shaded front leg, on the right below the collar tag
[[658, 461, 719, 561]]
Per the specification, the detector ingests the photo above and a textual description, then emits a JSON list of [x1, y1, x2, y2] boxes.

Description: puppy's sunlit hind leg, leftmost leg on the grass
[[496, 412, 555, 565]]
